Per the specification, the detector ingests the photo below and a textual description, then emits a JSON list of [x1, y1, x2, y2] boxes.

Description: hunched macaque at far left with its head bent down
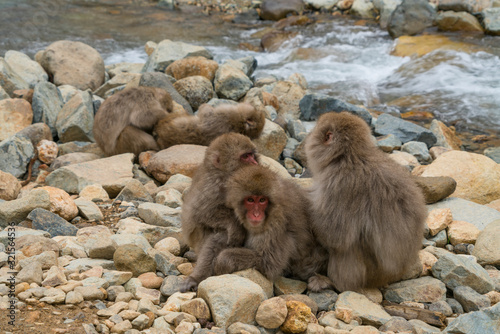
[[94, 87, 173, 157]]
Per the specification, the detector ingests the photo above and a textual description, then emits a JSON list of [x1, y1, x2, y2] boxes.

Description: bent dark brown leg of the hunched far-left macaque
[[114, 125, 159, 157]]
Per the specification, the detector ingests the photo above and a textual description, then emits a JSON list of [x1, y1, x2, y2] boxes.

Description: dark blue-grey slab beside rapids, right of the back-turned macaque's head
[[375, 114, 437, 148]]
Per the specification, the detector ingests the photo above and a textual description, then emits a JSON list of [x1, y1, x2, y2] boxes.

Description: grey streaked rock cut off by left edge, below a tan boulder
[[0, 135, 35, 178]]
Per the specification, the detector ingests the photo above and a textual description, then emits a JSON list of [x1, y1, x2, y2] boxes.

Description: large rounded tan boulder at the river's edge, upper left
[[37, 41, 105, 91]]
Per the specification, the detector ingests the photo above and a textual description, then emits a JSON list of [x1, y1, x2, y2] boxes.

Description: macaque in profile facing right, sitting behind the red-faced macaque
[[181, 133, 258, 291]]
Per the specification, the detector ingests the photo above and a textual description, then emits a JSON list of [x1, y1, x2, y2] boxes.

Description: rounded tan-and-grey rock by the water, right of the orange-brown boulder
[[214, 62, 253, 101]]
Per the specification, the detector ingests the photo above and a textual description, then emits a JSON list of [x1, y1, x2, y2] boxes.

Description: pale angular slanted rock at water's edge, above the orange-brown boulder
[[142, 39, 213, 73]]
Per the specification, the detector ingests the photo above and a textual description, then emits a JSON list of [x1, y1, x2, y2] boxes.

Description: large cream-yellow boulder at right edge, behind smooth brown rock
[[418, 151, 500, 204]]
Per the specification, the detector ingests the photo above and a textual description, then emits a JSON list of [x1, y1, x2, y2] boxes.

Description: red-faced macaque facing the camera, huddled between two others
[[214, 166, 330, 291]]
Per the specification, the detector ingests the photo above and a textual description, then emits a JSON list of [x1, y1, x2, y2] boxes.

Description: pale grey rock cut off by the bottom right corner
[[442, 303, 500, 334]]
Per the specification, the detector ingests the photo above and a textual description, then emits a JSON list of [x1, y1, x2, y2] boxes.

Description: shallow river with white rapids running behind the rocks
[[0, 0, 500, 141]]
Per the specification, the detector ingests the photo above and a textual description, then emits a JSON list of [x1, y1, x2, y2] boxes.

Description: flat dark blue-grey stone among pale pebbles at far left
[[28, 208, 78, 237]]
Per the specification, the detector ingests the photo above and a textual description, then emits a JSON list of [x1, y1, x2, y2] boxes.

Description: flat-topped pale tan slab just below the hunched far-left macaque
[[46, 153, 134, 197]]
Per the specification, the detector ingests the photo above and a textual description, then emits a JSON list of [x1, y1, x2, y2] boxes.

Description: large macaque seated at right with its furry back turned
[[306, 112, 427, 291]]
